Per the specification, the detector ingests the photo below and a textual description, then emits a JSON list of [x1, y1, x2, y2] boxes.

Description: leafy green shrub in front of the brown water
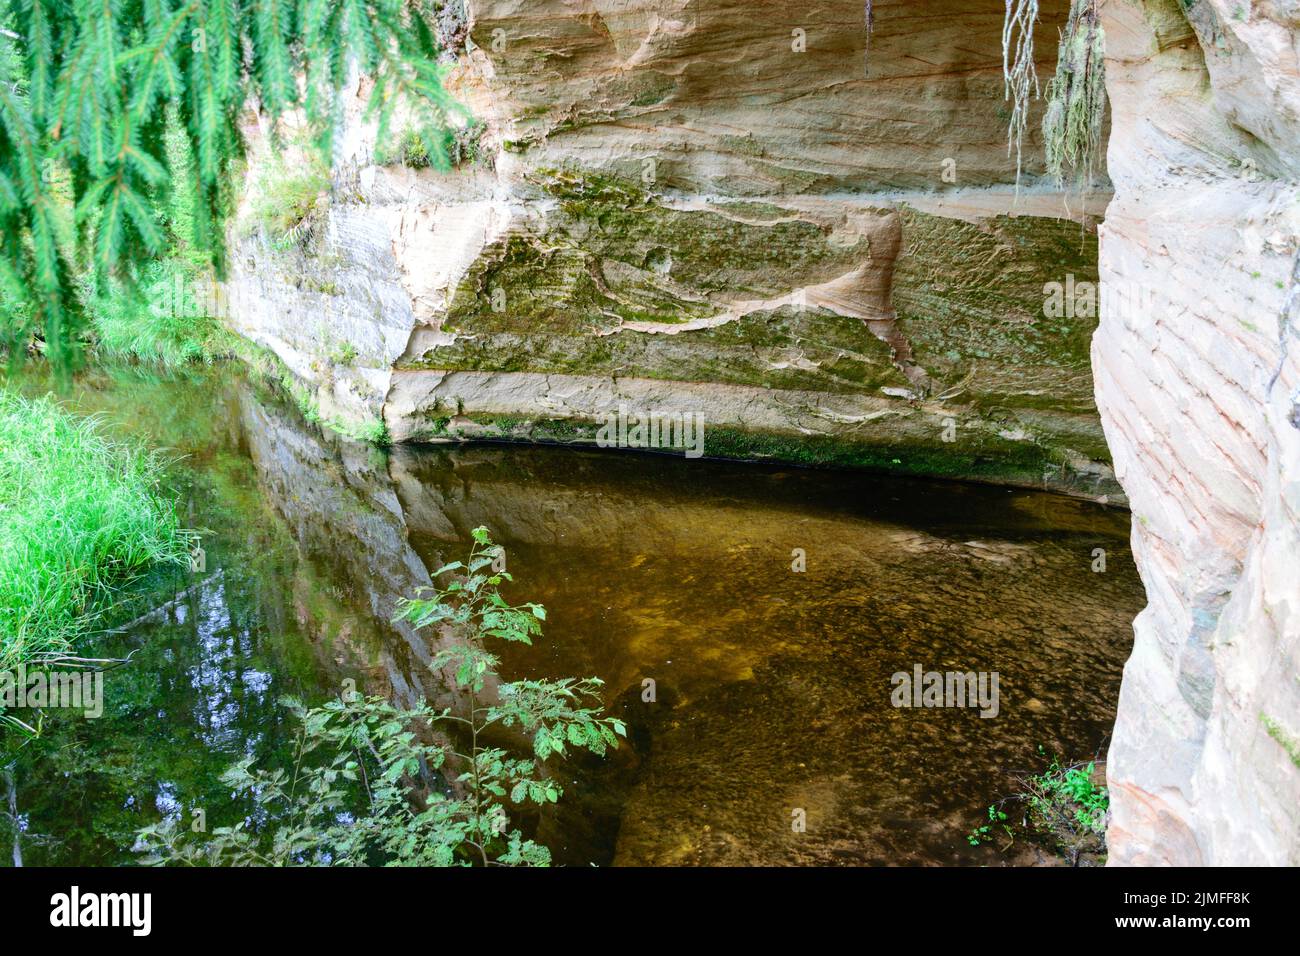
[[137, 528, 627, 866]]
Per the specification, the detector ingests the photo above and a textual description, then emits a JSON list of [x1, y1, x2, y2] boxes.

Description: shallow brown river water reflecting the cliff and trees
[[4, 368, 1143, 865]]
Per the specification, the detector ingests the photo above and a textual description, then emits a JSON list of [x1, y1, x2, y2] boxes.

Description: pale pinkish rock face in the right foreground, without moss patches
[[1092, 0, 1300, 865]]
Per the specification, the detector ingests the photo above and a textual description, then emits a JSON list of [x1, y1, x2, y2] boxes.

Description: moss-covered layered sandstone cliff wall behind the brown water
[[223, 0, 1119, 499]]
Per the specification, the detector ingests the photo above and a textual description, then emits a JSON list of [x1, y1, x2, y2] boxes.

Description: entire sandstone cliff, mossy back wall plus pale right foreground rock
[[215, 0, 1300, 864]]
